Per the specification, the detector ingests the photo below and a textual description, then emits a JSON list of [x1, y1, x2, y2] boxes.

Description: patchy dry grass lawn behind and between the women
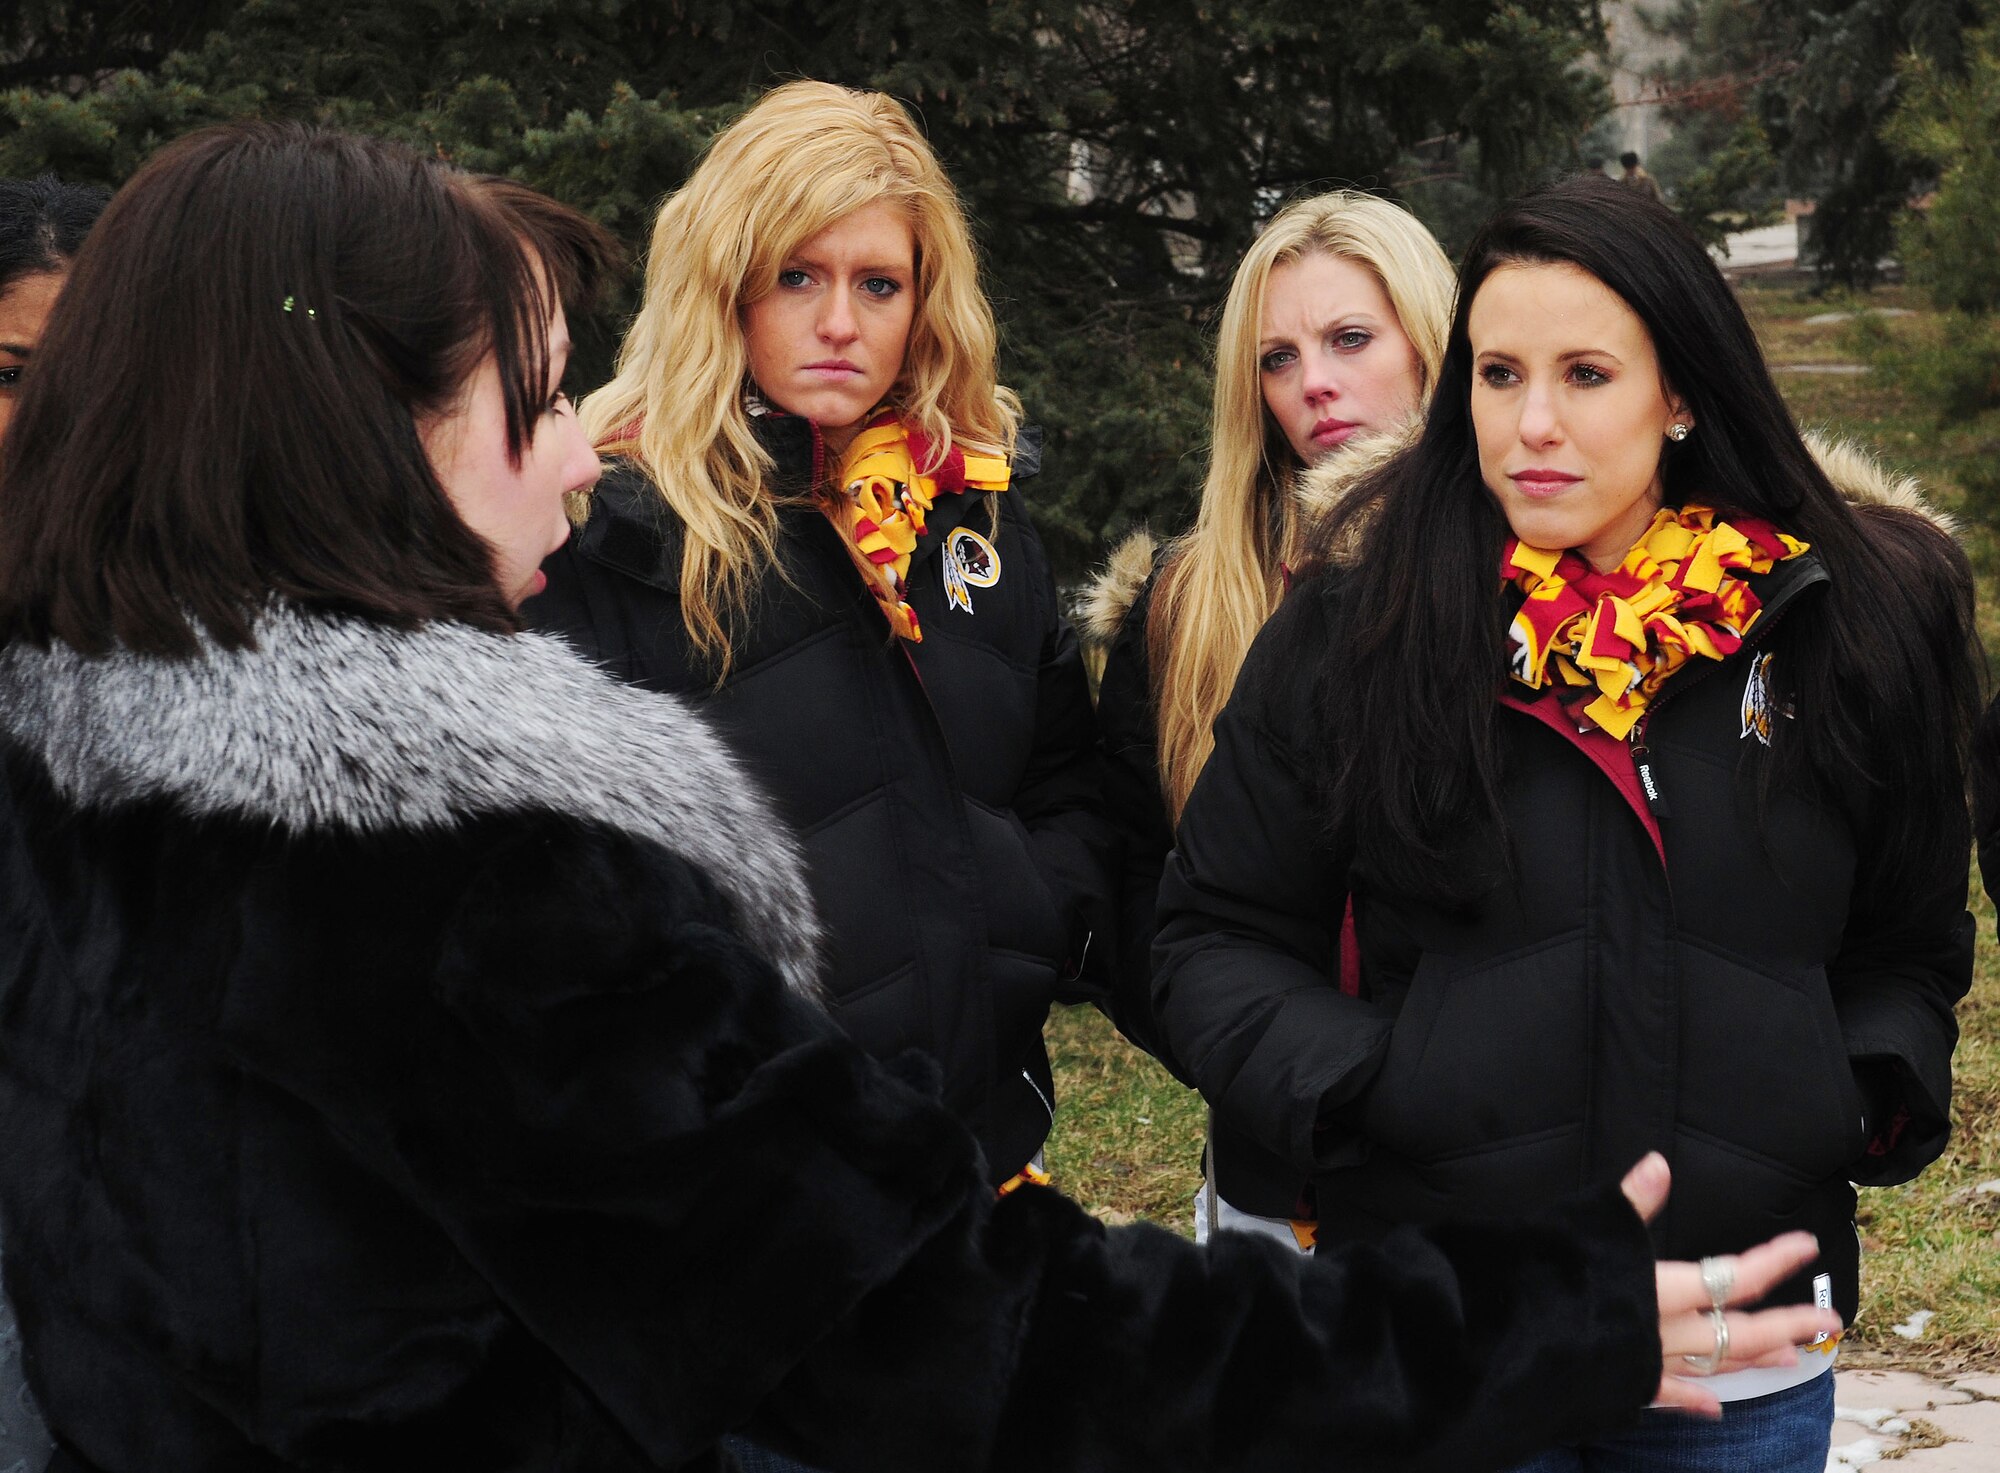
[[1048, 284, 2000, 1371]]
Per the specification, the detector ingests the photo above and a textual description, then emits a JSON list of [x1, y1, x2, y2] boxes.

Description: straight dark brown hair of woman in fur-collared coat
[[0, 124, 614, 654]]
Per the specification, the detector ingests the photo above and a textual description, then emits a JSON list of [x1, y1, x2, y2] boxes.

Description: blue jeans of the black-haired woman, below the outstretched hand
[[1510, 1371, 1834, 1473]]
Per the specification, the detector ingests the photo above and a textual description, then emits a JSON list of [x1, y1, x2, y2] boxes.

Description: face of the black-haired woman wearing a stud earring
[[1466, 264, 1694, 572]]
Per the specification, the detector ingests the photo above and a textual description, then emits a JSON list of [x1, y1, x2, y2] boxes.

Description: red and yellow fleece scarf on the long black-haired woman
[[1500, 506, 1808, 741]]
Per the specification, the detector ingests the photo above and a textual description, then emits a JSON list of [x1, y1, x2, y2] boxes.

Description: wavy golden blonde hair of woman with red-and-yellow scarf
[[582, 82, 1020, 678]]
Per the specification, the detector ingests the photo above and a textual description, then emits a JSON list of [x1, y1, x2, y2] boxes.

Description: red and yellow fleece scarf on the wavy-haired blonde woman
[[822, 408, 1008, 644]]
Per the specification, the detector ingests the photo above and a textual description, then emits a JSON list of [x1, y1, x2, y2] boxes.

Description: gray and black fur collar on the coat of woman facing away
[[0, 602, 818, 993]]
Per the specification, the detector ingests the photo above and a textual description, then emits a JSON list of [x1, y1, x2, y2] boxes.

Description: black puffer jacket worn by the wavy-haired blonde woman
[[526, 414, 1112, 1181]]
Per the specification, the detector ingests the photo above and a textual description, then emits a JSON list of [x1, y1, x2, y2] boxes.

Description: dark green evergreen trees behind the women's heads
[[0, 0, 1604, 570]]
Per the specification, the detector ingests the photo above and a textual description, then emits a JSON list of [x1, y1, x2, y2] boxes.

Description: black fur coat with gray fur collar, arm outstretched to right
[[0, 606, 1658, 1473]]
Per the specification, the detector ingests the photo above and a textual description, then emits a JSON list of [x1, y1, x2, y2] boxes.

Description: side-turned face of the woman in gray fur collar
[[422, 306, 602, 608]]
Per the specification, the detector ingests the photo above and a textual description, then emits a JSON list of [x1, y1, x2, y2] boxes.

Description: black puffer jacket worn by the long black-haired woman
[[1154, 500, 1972, 1317]]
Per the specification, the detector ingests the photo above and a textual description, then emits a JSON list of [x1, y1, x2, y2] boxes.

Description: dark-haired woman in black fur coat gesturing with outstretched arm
[[0, 126, 1836, 1473]]
